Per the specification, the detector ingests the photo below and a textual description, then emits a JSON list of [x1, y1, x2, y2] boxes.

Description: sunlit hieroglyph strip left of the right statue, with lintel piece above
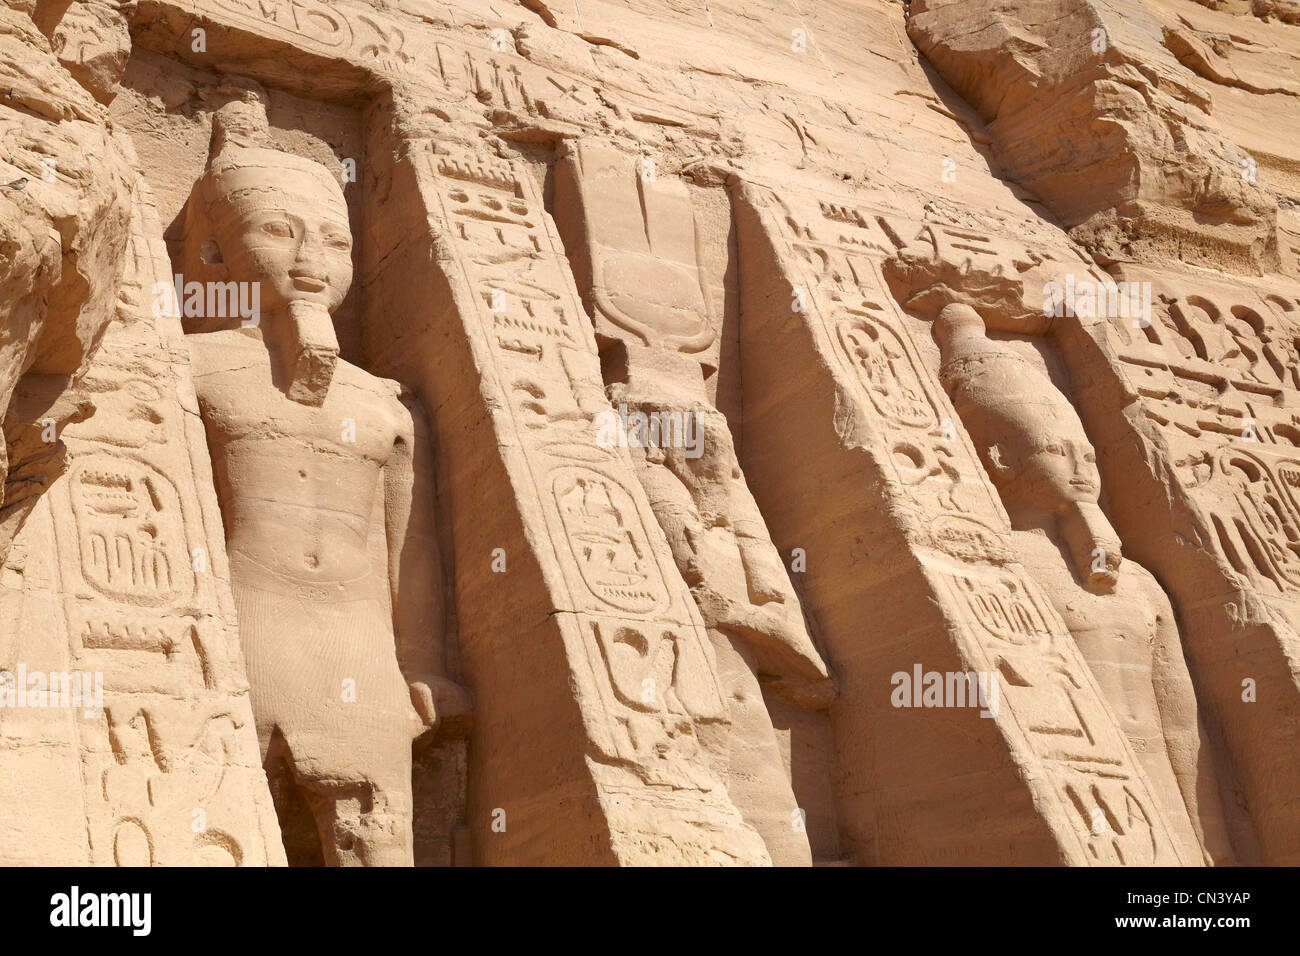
[[749, 189, 1178, 864]]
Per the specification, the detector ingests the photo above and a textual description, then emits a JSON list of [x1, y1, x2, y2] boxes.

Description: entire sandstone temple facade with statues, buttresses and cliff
[[0, 0, 1300, 866]]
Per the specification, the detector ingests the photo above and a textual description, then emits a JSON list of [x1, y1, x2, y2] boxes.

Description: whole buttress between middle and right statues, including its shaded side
[[735, 183, 1187, 864]]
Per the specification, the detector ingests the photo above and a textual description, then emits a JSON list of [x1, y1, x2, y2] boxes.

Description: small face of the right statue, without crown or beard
[[988, 419, 1101, 511]]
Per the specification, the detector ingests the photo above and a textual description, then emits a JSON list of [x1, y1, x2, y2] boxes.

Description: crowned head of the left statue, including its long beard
[[181, 94, 352, 405]]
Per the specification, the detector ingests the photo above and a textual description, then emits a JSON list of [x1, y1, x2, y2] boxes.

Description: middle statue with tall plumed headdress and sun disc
[[556, 144, 833, 866]]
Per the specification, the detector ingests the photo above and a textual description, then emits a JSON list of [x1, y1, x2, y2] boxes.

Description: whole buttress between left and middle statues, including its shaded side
[[367, 130, 768, 864]]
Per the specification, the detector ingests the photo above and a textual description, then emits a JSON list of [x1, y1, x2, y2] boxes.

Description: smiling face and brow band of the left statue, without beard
[[212, 165, 352, 312]]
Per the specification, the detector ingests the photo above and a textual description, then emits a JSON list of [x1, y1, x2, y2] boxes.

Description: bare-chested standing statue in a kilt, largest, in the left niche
[[172, 100, 456, 865]]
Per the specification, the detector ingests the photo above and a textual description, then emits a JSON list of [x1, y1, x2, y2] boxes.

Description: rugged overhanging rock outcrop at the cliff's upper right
[[907, 0, 1278, 272]]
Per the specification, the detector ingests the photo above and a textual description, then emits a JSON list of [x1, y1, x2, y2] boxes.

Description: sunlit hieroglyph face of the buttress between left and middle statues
[[421, 144, 724, 791]]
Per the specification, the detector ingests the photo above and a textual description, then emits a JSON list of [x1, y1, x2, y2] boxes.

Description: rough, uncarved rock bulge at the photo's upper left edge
[[0, 3, 134, 553]]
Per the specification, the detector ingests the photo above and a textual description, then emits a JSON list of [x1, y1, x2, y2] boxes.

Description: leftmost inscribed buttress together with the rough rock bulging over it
[[0, 0, 285, 866]]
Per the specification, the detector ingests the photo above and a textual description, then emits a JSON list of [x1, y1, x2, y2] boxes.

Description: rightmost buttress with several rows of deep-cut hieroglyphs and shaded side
[[1060, 268, 1300, 864]]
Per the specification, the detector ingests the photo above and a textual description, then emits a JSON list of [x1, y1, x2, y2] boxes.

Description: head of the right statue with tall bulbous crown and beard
[[935, 304, 1119, 585]]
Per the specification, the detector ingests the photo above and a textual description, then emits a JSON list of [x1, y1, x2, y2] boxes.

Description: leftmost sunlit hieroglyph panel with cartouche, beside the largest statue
[[41, 170, 283, 865]]
